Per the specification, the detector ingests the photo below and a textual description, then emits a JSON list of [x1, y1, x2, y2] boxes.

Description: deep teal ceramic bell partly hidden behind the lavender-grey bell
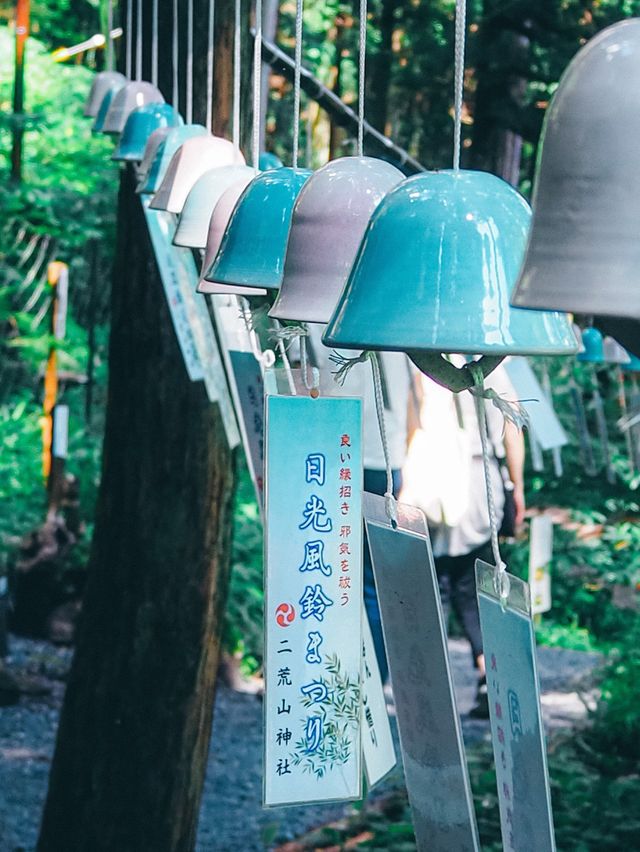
[[202, 168, 311, 290]]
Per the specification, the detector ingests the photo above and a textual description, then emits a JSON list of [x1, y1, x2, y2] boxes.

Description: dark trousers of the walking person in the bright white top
[[435, 542, 493, 666]]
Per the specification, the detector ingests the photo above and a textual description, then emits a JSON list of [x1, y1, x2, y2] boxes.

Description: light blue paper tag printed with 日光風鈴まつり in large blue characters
[[264, 371, 363, 805]]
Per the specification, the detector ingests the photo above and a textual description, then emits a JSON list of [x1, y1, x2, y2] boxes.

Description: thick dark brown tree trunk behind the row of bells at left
[[38, 0, 234, 852]]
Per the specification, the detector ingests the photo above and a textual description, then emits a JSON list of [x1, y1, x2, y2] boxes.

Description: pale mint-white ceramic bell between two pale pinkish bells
[[173, 166, 256, 248]]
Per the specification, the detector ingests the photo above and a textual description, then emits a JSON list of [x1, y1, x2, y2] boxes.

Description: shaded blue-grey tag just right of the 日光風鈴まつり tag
[[364, 493, 480, 852]]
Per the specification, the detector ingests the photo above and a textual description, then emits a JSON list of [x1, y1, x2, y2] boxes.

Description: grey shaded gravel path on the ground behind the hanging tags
[[0, 639, 598, 852]]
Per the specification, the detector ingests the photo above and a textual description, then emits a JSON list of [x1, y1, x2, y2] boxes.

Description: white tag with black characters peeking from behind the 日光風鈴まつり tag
[[362, 604, 396, 788]]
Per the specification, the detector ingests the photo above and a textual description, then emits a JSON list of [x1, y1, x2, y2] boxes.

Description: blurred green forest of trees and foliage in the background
[[0, 0, 640, 850]]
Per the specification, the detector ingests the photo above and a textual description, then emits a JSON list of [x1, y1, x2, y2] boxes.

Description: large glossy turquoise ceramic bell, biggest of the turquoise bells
[[324, 171, 578, 378]]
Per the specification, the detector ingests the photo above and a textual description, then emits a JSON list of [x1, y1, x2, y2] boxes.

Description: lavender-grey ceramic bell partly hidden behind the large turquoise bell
[[269, 157, 403, 323]]
